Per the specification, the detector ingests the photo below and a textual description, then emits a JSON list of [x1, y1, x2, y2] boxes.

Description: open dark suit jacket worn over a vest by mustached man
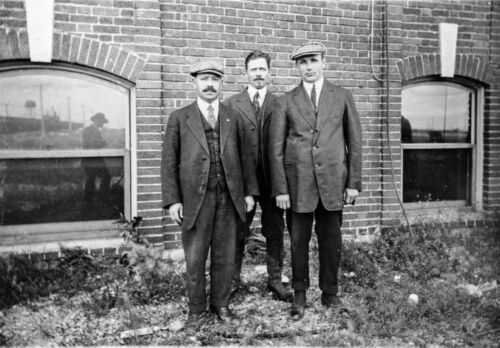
[[161, 102, 259, 229]]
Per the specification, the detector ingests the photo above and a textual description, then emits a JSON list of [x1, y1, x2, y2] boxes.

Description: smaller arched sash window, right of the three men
[[401, 80, 482, 208]]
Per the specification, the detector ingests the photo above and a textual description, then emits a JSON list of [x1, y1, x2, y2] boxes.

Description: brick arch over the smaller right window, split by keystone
[[397, 54, 493, 84]]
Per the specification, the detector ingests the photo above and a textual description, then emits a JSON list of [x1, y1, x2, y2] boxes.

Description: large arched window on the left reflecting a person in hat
[[0, 65, 130, 239]]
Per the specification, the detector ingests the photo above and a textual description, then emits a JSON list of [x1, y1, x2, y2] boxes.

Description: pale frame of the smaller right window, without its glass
[[399, 76, 485, 211]]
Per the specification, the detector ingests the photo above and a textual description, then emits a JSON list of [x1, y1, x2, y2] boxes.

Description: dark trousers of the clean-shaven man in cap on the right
[[287, 200, 342, 295]]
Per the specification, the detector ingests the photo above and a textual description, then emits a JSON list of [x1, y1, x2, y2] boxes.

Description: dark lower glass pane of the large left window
[[0, 157, 124, 225]]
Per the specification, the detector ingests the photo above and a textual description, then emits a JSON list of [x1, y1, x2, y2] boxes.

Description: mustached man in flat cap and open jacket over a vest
[[161, 60, 259, 323]]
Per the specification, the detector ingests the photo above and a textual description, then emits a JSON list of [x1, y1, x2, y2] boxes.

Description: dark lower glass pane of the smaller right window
[[403, 149, 472, 203]]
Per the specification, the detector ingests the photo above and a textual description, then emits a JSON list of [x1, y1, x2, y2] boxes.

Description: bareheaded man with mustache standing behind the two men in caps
[[227, 51, 292, 301]]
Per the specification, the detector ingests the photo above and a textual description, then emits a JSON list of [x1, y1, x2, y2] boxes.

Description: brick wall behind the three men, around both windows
[[0, 0, 500, 248]]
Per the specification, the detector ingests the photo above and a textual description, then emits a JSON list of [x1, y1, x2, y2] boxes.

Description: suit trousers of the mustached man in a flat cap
[[182, 179, 241, 314]]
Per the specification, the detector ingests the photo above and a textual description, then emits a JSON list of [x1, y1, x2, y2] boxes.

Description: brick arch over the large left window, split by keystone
[[0, 28, 146, 83]]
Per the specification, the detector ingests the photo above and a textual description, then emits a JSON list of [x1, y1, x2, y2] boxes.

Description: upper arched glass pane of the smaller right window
[[401, 83, 475, 143]]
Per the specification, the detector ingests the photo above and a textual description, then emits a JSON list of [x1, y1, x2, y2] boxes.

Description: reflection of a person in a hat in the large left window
[[82, 113, 110, 203]]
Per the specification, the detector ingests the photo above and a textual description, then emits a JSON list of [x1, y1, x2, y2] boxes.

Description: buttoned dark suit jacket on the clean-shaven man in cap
[[269, 79, 362, 212]]
